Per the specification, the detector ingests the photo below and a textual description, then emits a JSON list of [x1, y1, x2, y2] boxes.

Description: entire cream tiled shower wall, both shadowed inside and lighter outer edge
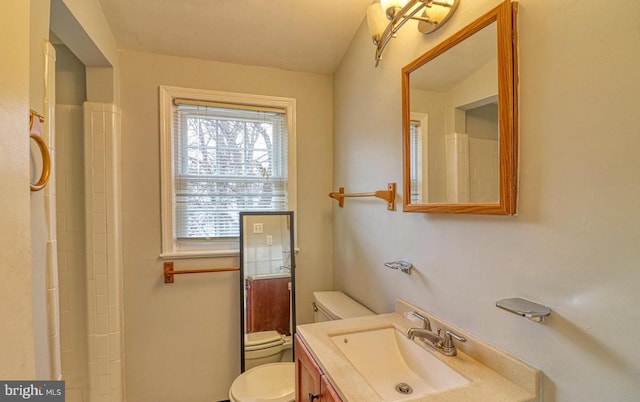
[[56, 102, 124, 402]]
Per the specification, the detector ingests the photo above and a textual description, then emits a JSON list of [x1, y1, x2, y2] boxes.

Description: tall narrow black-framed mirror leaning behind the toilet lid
[[240, 211, 295, 372]]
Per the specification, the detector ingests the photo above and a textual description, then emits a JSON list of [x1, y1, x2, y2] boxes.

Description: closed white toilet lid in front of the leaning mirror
[[229, 363, 296, 402]]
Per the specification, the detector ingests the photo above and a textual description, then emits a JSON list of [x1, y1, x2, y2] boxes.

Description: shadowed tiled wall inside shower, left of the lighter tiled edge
[[55, 105, 89, 402]]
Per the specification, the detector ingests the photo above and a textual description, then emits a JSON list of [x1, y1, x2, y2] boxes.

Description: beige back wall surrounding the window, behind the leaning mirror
[[120, 51, 333, 402]]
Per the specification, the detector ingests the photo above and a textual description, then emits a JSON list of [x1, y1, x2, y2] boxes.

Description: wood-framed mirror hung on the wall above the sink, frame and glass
[[402, 0, 518, 215]]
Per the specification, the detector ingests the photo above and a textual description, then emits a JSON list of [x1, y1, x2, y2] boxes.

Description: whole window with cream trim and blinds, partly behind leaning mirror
[[160, 87, 295, 258]]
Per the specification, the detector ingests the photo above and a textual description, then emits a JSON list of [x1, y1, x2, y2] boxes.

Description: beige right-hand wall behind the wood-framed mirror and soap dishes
[[334, 0, 640, 402]]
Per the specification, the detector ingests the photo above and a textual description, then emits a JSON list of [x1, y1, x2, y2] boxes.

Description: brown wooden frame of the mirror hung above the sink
[[402, 0, 518, 215]]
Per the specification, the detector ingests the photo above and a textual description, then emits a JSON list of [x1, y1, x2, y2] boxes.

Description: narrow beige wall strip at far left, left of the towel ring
[[0, 0, 36, 380]]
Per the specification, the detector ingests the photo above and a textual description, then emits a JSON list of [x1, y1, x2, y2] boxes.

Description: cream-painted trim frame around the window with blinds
[[159, 85, 297, 259]]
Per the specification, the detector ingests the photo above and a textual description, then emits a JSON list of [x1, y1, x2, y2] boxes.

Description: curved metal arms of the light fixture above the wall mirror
[[373, 0, 460, 67]]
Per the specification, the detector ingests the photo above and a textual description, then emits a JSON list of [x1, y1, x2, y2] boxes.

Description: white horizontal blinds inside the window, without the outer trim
[[172, 99, 288, 240]]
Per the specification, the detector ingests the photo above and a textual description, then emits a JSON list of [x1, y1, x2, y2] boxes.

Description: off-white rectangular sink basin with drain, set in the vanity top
[[331, 327, 469, 402]]
